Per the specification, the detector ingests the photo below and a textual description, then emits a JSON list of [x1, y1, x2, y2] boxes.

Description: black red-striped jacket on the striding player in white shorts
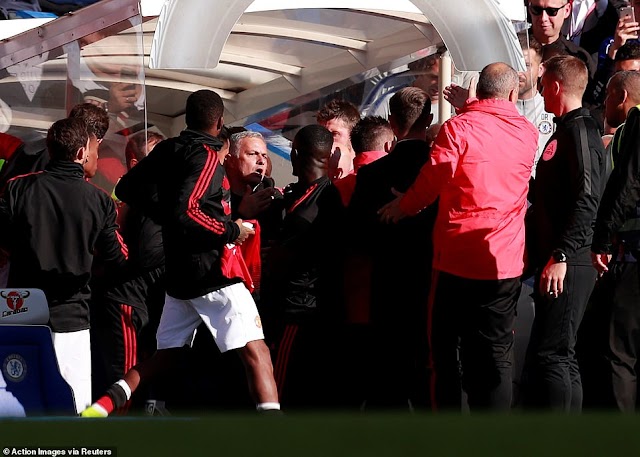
[[115, 130, 240, 300]]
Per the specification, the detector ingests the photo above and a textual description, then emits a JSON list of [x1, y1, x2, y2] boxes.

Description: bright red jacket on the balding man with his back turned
[[400, 99, 538, 280]]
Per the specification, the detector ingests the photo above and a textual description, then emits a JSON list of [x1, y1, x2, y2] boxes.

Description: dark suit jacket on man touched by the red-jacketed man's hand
[[348, 140, 437, 333]]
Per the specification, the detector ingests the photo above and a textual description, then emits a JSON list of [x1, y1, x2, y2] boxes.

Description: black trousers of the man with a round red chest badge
[[525, 265, 597, 412]]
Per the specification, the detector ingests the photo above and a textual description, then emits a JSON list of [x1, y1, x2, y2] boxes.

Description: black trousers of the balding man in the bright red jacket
[[428, 272, 521, 411]]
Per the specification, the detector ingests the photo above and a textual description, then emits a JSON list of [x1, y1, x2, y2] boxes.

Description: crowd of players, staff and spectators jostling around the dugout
[[0, 0, 640, 417]]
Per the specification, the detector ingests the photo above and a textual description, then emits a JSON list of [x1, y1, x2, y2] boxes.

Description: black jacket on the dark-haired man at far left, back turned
[[0, 160, 127, 332]]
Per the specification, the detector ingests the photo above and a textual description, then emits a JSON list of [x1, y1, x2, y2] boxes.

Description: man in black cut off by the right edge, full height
[[591, 71, 640, 412]]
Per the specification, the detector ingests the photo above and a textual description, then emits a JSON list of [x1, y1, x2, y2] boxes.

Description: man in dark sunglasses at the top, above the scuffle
[[527, 0, 596, 80]]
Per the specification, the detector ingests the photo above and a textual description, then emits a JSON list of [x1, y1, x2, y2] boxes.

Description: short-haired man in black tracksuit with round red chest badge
[[525, 55, 606, 412]]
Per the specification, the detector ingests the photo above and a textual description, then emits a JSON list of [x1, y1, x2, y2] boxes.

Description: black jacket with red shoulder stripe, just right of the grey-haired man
[[262, 176, 345, 324]]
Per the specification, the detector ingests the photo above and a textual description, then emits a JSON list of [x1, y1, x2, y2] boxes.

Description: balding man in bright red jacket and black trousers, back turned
[[379, 62, 538, 410]]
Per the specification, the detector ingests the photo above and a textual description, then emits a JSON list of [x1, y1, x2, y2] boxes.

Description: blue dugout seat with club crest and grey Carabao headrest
[[0, 289, 76, 416]]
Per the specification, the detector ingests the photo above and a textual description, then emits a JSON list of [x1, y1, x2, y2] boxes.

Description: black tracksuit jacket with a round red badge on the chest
[[528, 108, 606, 267]]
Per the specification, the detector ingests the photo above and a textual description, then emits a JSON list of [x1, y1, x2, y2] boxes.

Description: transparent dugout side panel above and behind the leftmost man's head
[[0, 9, 146, 193]]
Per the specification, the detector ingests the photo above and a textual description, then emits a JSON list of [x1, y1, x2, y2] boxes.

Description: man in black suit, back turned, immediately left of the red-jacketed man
[[349, 87, 436, 408]]
